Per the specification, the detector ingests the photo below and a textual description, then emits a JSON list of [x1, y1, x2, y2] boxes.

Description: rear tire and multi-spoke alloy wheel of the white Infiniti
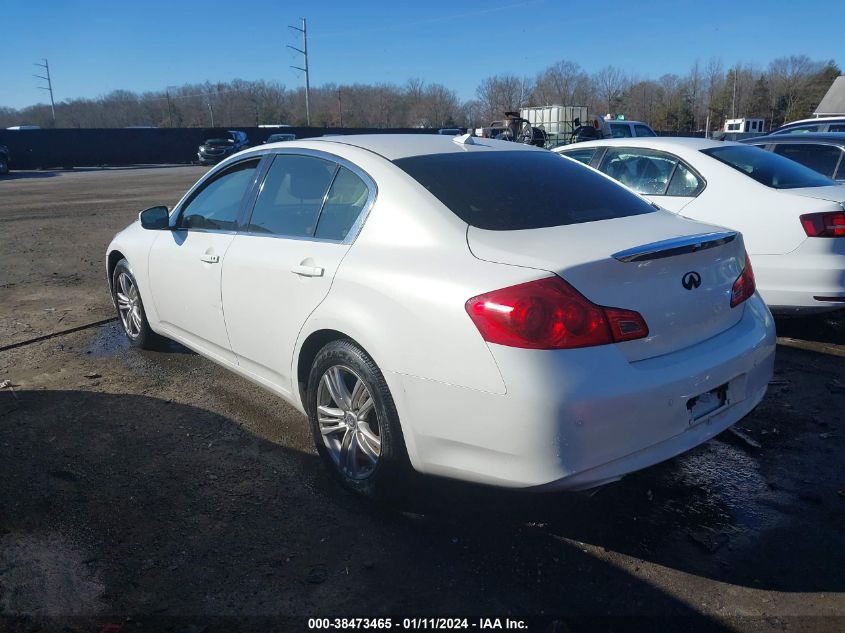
[[306, 339, 412, 501]]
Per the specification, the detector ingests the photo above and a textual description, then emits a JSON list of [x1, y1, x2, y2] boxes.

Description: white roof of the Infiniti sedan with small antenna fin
[[263, 133, 545, 161]]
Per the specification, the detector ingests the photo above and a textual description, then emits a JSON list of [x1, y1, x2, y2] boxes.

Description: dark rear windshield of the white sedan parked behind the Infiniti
[[701, 145, 836, 189]]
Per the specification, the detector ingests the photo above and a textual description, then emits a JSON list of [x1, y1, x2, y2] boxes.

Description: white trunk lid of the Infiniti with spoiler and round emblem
[[467, 211, 753, 361]]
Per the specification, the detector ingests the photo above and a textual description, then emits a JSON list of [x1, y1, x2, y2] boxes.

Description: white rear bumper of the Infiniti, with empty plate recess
[[390, 295, 775, 490]]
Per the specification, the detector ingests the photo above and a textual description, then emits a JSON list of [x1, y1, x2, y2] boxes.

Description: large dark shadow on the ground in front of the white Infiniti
[[0, 391, 845, 630]]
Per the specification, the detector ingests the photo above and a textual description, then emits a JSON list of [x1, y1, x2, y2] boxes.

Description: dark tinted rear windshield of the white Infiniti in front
[[394, 151, 655, 231]]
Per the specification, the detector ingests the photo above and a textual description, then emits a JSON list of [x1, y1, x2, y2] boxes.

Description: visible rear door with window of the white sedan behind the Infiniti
[[598, 147, 705, 213]]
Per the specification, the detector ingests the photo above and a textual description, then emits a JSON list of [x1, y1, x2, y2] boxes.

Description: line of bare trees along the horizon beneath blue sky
[[0, 55, 841, 132]]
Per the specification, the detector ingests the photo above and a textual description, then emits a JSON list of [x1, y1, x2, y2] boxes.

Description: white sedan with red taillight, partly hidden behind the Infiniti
[[555, 138, 845, 313]]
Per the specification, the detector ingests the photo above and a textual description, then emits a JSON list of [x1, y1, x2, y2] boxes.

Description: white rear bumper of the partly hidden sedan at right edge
[[752, 243, 845, 314]]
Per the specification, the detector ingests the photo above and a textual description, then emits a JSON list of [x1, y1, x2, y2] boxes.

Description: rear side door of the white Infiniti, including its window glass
[[222, 150, 375, 394]]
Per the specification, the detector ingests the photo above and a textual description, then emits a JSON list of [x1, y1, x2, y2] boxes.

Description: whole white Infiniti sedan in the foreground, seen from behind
[[107, 135, 775, 495]]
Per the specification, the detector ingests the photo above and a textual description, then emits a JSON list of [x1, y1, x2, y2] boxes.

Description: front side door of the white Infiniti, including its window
[[149, 159, 259, 363]]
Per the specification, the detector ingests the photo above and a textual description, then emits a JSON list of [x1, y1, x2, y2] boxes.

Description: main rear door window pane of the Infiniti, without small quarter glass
[[246, 154, 337, 237]]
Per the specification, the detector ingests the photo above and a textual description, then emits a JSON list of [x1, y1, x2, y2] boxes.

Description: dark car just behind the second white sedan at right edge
[[743, 133, 845, 184]]
